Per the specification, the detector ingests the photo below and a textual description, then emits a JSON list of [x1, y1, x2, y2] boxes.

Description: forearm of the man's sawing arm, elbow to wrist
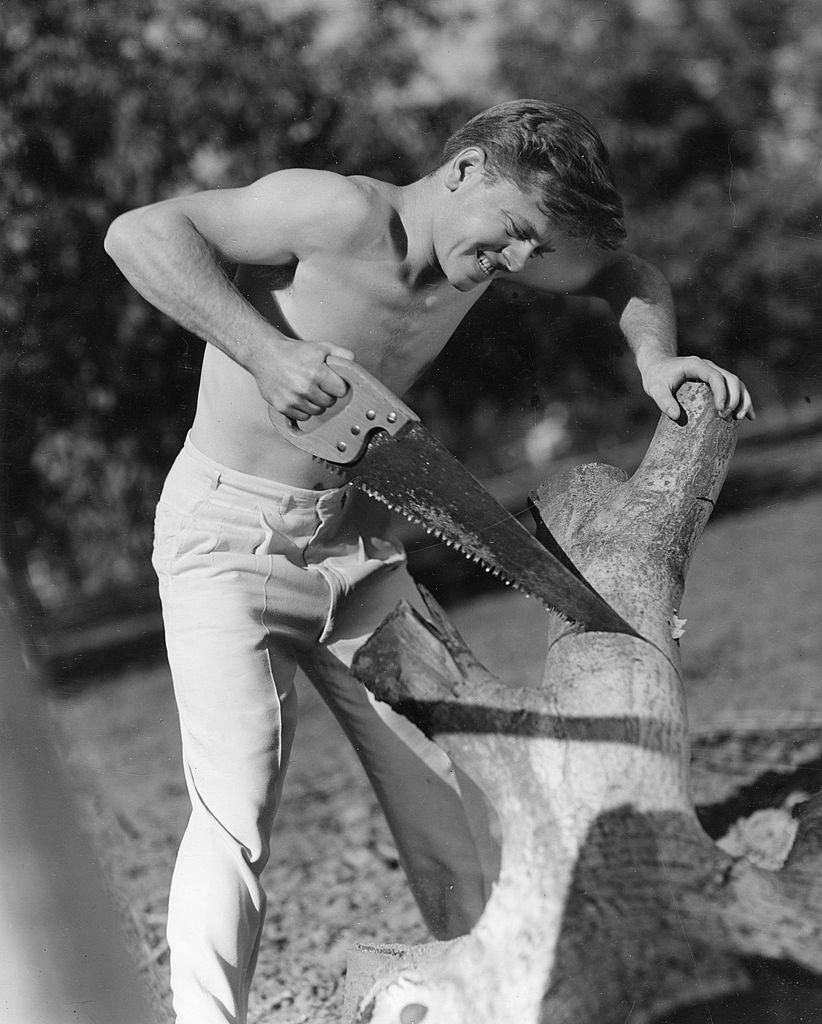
[[105, 207, 286, 372]]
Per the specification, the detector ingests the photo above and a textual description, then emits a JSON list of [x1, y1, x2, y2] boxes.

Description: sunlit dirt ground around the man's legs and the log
[[51, 494, 822, 1024]]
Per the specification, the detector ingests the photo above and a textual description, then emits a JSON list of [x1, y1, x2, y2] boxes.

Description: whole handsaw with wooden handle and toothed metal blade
[[269, 356, 639, 636]]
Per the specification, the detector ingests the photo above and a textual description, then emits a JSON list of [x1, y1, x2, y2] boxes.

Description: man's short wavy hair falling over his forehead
[[442, 99, 626, 250]]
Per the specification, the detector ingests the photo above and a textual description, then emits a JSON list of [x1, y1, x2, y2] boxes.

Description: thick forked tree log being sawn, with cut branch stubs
[[347, 384, 822, 1024]]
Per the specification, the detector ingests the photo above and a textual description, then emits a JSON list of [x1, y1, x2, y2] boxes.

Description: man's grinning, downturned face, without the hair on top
[[434, 164, 559, 292]]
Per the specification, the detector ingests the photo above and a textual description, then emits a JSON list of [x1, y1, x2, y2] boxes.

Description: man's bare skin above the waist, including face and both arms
[[105, 119, 753, 499]]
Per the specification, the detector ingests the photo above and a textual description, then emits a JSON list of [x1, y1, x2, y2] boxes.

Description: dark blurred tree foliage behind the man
[[0, 0, 822, 602]]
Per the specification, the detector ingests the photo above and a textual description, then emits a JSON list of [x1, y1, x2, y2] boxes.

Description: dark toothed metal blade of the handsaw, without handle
[[330, 421, 639, 636]]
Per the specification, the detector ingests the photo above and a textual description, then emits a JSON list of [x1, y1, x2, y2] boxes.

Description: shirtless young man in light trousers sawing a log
[[106, 100, 753, 1024]]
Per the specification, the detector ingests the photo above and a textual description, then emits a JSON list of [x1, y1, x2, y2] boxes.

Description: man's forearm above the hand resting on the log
[[591, 253, 677, 375]]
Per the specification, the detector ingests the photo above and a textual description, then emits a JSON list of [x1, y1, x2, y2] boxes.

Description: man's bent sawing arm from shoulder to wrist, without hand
[[105, 170, 372, 379]]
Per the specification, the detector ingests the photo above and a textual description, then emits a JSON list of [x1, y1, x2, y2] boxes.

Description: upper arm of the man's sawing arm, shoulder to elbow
[[149, 170, 364, 264]]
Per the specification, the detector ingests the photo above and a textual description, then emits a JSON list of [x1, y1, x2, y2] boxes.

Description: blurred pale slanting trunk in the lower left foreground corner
[[0, 559, 159, 1024]]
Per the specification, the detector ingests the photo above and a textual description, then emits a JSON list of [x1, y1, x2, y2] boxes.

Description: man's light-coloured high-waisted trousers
[[154, 439, 497, 1024]]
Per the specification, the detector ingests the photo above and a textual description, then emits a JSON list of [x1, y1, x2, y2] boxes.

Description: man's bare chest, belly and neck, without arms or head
[[191, 178, 485, 488]]
